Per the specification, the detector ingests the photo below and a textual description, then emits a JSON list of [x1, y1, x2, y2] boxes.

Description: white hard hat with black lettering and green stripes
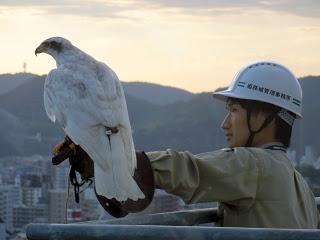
[[213, 61, 302, 121]]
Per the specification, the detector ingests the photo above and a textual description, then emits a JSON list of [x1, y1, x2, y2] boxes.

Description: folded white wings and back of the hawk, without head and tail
[[44, 63, 136, 172]]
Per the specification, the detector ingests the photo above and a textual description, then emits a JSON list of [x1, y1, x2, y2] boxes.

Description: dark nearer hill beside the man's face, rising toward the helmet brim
[[135, 93, 226, 153]]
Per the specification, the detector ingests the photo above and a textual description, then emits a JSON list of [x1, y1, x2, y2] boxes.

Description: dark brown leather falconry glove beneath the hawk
[[52, 137, 155, 217]]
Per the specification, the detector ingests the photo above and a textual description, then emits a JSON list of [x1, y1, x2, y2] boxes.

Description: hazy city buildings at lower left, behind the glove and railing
[[0, 156, 190, 240]]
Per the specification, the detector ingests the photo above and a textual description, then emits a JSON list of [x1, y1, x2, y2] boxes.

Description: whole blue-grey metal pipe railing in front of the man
[[26, 198, 320, 240]]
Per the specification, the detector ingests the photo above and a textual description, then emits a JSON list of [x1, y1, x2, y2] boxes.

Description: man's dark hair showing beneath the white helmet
[[228, 98, 295, 148]]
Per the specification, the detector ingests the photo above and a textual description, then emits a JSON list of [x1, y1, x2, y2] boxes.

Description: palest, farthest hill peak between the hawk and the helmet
[[122, 82, 194, 106]]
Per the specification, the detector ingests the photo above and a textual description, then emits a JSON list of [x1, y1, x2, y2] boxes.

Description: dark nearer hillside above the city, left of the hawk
[[0, 76, 63, 155]]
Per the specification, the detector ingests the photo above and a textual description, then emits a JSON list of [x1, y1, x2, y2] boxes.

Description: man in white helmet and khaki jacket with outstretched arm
[[53, 62, 319, 228]]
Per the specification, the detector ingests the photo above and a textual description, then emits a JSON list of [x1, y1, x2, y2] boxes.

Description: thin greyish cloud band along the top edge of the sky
[[0, 0, 320, 18]]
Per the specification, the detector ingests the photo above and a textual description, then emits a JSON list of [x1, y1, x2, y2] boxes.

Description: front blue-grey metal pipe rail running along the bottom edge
[[27, 224, 320, 240]]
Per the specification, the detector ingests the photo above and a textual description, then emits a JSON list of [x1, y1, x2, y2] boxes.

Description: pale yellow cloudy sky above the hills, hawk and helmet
[[0, 0, 320, 93]]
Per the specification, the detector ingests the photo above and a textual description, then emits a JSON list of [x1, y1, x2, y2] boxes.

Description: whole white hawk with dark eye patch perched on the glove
[[36, 37, 144, 201]]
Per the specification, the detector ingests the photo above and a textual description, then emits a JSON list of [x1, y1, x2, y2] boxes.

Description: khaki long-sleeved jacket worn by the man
[[147, 143, 319, 228]]
